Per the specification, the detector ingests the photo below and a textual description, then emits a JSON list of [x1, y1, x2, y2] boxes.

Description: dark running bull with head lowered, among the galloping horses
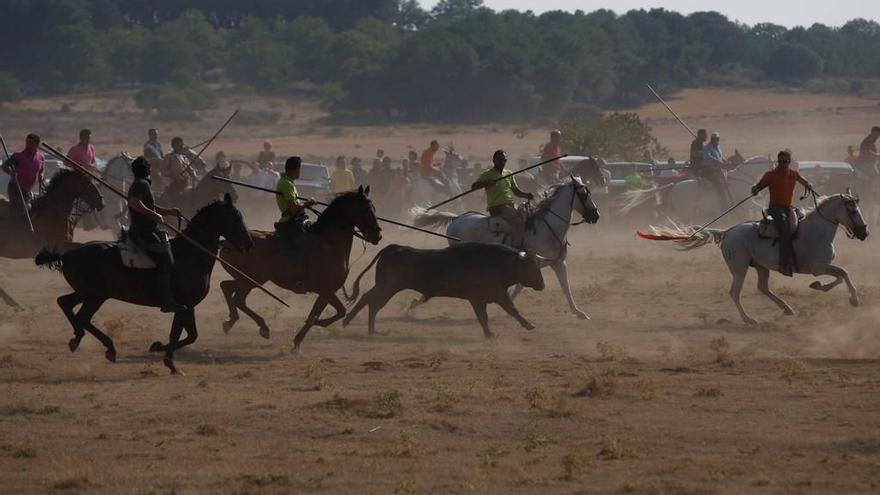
[[344, 242, 544, 338]]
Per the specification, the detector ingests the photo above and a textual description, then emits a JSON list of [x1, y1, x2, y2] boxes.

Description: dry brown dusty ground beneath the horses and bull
[[0, 226, 880, 493]]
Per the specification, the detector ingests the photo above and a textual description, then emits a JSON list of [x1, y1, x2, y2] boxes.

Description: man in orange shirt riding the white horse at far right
[[752, 151, 813, 277]]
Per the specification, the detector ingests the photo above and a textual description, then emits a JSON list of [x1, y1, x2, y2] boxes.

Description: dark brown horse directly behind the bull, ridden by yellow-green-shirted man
[[220, 187, 382, 350]]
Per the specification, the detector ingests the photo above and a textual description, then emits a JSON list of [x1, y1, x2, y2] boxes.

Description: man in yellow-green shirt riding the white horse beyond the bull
[[471, 150, 535, 249]]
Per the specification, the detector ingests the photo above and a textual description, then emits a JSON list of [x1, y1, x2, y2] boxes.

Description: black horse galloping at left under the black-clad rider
[[34, 196, 253, 373]]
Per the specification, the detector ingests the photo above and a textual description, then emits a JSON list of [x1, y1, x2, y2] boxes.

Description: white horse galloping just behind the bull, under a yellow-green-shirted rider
[[415, 177, 599, 319]]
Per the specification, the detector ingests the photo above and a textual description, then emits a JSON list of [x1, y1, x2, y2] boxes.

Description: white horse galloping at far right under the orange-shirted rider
[[654, 193, 868, 324]]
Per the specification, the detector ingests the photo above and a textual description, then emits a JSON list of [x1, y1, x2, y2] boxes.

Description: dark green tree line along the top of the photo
[[0, 0, 880, 122]]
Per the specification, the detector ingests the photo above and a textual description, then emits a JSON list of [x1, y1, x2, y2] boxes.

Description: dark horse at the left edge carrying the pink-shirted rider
[[0, 169, 104, 259]]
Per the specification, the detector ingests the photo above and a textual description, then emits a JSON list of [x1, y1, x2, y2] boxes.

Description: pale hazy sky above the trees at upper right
[[420, 0, 880, 27]]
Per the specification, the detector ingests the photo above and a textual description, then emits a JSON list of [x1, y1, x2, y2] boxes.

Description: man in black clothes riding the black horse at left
[[128, 156, 187, 313]]
